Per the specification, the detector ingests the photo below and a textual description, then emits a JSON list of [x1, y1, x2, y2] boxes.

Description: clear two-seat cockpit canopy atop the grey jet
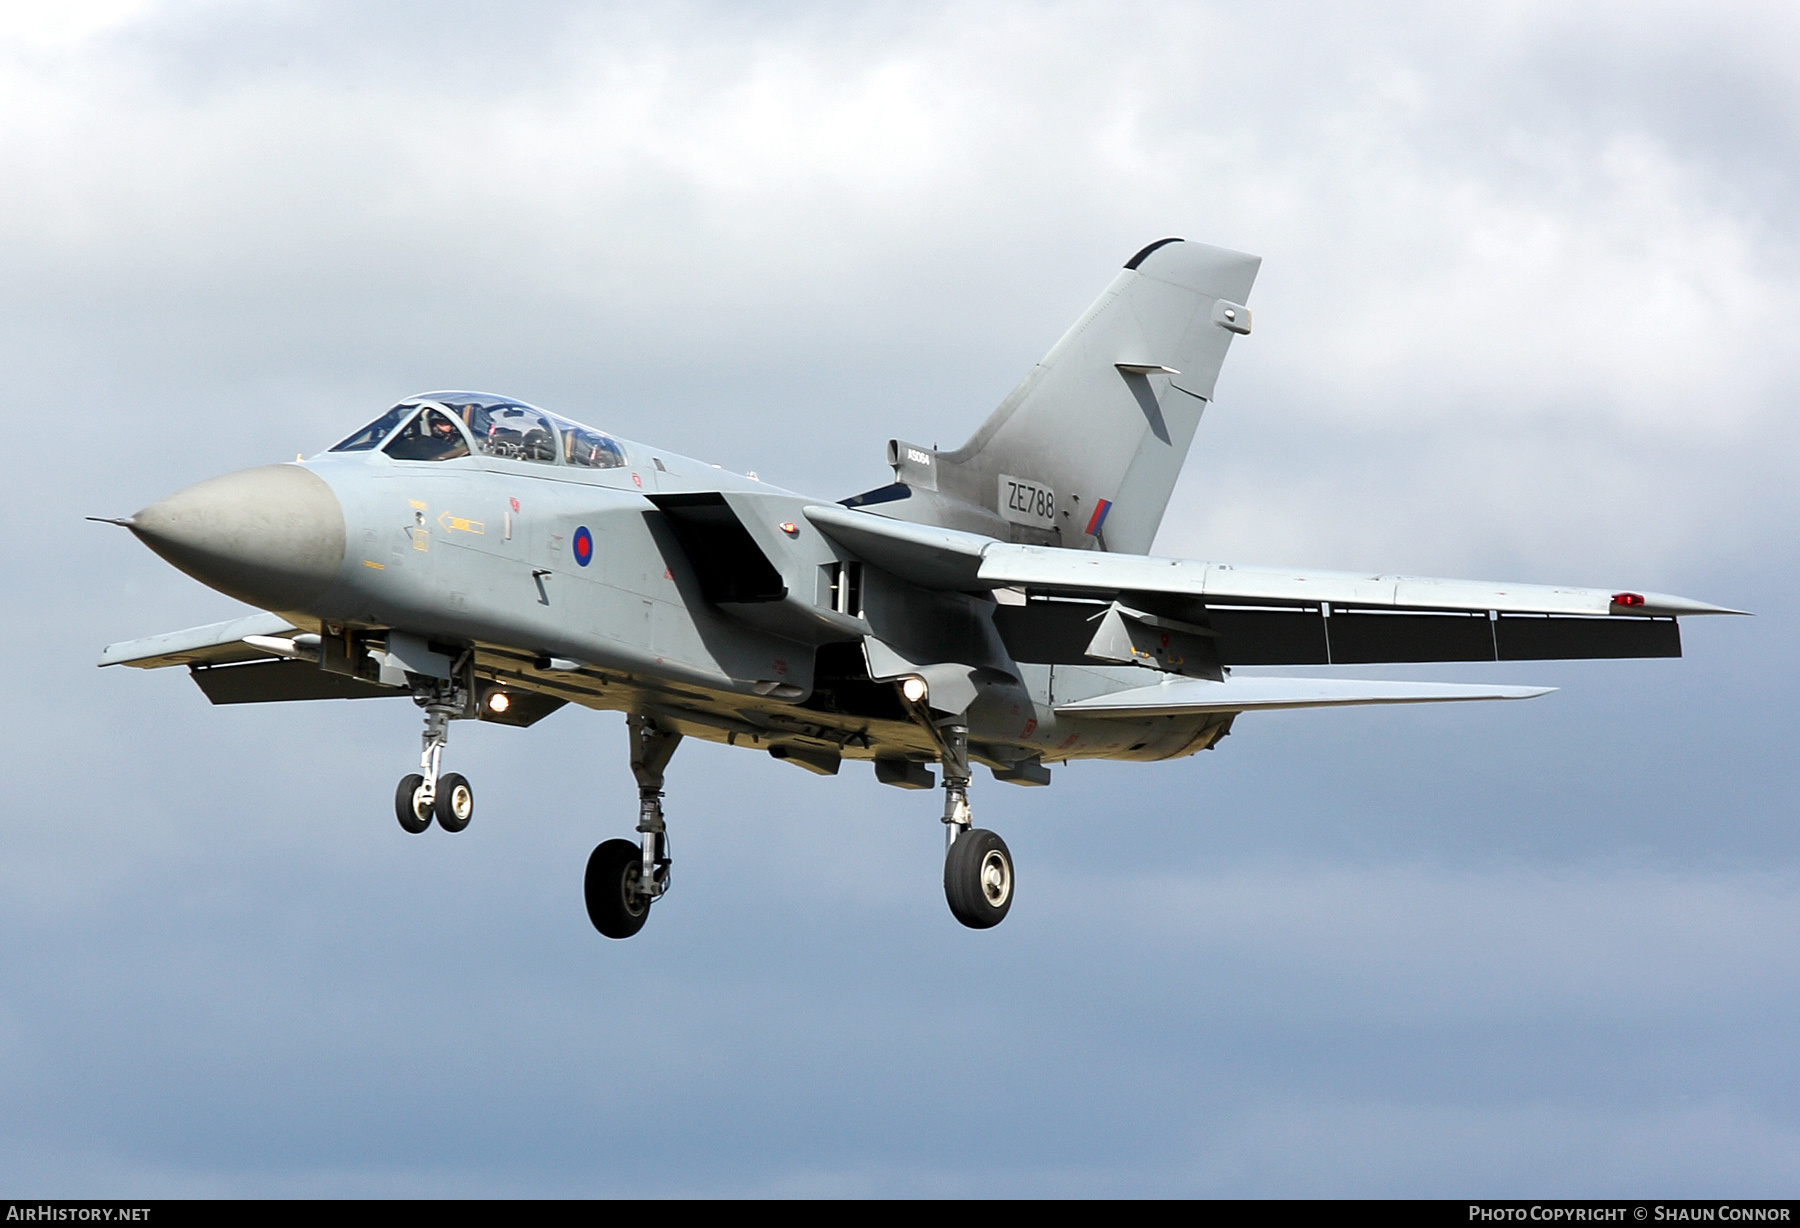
[[331, 393, 625, 468]]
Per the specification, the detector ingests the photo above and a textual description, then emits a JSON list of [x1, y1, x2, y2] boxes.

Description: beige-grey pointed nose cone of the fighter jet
[[130, 465, 344, 610]]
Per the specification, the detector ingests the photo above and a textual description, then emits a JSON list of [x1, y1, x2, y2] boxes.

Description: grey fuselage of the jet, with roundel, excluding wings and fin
[[123, 398, 1229, 767]]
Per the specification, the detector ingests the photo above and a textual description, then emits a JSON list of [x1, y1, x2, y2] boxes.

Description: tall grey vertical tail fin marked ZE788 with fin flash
[[860, 239, 1262, 555]]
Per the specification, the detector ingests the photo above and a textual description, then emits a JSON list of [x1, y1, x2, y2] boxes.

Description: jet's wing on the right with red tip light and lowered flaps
[[806, 506, 1741, 677]]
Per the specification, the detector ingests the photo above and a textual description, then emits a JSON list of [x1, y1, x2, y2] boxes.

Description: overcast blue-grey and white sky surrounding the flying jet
[[0, 2, 1800, 1196]]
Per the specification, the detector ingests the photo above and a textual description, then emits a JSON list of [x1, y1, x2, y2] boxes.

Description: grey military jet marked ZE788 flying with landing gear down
[[101, 239, 1737, 938]]
